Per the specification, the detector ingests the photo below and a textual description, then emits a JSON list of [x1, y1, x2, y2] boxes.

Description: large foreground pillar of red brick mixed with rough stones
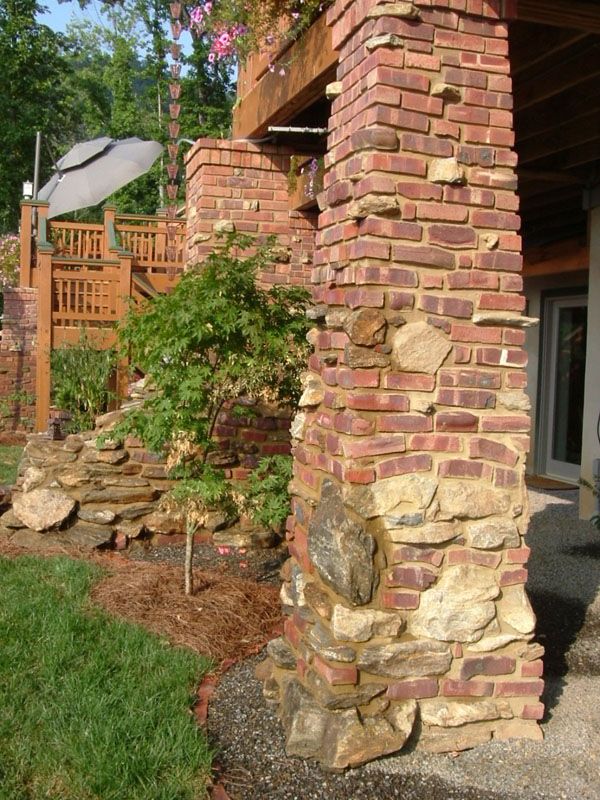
[[265, 0, 543, 768]]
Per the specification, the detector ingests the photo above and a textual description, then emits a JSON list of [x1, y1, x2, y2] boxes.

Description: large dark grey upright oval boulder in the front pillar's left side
[[308, 481, 376, 605]]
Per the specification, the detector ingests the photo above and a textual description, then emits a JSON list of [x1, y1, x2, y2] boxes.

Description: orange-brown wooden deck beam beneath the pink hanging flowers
[[233, 14, 338, 138]]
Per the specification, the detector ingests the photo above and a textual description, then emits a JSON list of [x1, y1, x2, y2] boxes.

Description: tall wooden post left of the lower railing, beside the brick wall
[[35, 247, 52, 433]]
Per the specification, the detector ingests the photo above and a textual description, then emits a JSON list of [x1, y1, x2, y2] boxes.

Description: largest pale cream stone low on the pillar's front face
[[409, 564, 500, 642]]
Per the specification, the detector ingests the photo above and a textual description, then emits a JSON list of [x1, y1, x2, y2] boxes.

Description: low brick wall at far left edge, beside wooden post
[[0, 288, 37, 431]]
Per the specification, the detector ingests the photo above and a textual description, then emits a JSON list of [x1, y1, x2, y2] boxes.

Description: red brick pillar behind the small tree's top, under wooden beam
[[186, 139, 317, 285]]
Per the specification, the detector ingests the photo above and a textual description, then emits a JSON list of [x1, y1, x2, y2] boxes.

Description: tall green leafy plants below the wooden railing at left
[[50, 328, 116, 433]]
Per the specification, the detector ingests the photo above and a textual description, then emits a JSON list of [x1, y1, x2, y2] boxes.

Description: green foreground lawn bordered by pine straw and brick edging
[[0, 557, 211, 800]]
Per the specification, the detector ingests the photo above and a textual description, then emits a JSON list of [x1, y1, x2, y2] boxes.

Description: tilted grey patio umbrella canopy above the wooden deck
[[38, 137, 163, 218]]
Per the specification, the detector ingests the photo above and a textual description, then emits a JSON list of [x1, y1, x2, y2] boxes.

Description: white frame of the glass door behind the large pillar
[[535, 286, 589, 484]]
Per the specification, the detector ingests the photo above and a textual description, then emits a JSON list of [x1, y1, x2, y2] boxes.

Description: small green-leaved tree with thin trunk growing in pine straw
[[118, 234, 309, 591]]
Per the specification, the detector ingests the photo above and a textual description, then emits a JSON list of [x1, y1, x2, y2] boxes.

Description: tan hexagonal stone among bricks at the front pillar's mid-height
[[392, 322, 452, 375]]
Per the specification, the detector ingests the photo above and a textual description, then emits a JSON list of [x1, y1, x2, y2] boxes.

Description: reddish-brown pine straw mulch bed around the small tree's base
[[0, 537, 281, 670]]
